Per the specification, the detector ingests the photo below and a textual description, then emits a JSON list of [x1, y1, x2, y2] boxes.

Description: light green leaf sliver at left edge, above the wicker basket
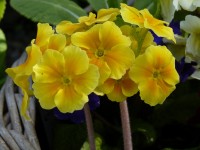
[[0, 29, 7, 87]]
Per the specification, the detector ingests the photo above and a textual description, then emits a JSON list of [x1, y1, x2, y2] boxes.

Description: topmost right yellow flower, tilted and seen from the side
[[120, 4, 176, 42]]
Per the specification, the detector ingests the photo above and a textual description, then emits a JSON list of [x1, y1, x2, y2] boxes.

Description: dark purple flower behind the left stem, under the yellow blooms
[[54, 93, 100, 123]]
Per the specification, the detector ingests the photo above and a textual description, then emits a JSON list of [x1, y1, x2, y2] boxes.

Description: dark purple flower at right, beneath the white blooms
[[176, 57, 197, 82]]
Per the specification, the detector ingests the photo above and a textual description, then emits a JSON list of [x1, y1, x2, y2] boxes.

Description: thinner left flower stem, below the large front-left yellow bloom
[[84, 103, 96, 150]]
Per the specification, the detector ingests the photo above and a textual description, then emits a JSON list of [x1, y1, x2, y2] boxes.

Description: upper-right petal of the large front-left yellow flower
[[62, 46, 89, 76]]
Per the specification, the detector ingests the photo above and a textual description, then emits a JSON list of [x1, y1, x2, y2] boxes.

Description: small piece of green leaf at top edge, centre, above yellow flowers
[[87, 0, 109, 11]]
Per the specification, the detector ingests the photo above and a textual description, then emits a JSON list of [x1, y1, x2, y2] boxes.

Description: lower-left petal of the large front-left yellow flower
[[33, 82, 60, 109]]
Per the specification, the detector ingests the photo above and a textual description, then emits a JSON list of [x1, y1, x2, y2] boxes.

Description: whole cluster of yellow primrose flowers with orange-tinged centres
[[6, 3, 179, 115]]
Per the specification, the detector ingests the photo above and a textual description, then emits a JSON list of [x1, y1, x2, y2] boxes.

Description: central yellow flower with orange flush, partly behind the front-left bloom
[[71, 21, 134, 84]]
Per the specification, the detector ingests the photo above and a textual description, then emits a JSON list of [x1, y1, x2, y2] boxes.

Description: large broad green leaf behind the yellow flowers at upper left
[[11, 0, 86, 25]]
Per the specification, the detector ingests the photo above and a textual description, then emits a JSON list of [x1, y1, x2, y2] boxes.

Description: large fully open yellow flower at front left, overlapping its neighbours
[[33, 46, 99, 113]]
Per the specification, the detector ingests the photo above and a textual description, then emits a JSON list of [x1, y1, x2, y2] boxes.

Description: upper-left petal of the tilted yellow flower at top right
[[120, 3, 144, 28]]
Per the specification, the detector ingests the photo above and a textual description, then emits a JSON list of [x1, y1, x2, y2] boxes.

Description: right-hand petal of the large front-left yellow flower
[[72, 64, 99, 95]]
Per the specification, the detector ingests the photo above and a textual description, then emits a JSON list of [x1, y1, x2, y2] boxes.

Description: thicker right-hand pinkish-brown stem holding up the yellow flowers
[[119, 100, 133, 150]]
